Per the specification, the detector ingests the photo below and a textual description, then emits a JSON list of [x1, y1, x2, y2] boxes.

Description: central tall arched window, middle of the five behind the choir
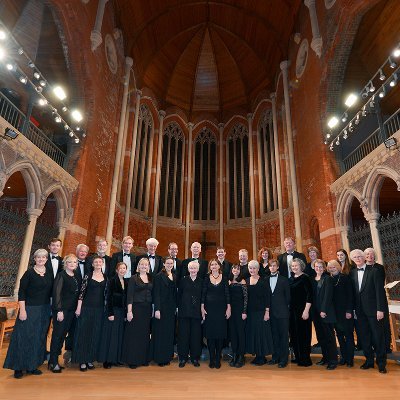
[[193, 128, 217, 221]]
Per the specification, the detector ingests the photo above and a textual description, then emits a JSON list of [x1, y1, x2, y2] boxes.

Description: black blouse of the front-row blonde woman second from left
[[52, 271, 79, 311]]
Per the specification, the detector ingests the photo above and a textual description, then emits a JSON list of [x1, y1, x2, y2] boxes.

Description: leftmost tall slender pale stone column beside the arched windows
[[106, 57, 133, 252]]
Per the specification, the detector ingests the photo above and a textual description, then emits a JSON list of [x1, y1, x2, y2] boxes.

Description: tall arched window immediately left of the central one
[[158, 122, 185, 218]]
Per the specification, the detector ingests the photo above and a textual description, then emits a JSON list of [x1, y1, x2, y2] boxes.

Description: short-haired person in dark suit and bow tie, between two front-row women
[[267, 259, 290, 368]]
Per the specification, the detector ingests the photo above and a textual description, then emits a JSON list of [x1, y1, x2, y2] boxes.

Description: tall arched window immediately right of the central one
[[226, 124, 250, 219]]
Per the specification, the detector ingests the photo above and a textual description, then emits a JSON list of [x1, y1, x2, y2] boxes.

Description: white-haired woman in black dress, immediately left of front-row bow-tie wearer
[[246, 260, 272, 365]]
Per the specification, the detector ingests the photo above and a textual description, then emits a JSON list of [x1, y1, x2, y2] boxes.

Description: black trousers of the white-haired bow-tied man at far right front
[[357, 313, 386, 368]]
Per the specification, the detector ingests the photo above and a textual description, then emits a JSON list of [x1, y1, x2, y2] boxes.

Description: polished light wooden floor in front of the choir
[[0, 343, 400, 400]]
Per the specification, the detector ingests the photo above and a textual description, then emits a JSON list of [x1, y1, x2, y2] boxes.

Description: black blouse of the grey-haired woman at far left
[[18, 268, 54, 306]]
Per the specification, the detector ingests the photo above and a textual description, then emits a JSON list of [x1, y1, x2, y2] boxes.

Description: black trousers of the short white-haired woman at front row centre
[[178, 318, 201, 361]]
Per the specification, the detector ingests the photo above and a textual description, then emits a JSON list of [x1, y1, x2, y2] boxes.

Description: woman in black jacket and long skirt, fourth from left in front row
[[98, 262, 128, 369]]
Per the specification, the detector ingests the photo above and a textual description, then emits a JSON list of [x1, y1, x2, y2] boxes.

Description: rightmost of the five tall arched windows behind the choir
[[257, 110, 278, 213]]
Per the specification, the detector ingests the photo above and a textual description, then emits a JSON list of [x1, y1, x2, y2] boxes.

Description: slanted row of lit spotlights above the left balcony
[[0, 20, 86, 143]]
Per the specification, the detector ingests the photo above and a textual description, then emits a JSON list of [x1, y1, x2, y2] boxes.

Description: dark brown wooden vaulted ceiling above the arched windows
[[114, 0, 302, 120]]
